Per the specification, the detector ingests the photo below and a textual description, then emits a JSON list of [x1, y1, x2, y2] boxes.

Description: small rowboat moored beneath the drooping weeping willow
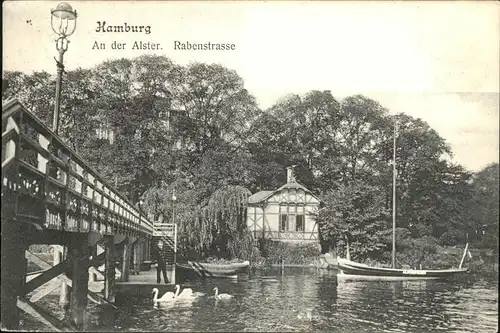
[[175, 260, 250, 278]]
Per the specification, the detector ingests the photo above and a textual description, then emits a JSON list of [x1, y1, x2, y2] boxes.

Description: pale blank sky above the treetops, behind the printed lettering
[[2, 1, 500, 171]]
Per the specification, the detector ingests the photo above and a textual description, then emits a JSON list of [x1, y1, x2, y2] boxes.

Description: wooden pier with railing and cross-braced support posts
[[1, 100, 175, 330]]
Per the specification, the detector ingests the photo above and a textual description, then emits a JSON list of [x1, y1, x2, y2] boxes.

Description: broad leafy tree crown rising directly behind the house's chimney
[[248, 91, 339, 190]]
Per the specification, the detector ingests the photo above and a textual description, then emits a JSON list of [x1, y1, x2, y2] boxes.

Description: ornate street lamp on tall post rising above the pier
[[50, 2, 76, 134]]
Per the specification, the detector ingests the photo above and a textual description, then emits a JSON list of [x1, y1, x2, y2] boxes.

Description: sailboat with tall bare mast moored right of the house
[[337, 123, 469, 280]]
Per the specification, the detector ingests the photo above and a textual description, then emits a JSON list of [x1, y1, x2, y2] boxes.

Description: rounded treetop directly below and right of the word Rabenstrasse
[[174, 63, 258, 157]]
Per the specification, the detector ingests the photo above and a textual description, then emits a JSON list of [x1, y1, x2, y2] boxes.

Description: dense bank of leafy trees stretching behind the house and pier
[[2, 56, 498, 260]]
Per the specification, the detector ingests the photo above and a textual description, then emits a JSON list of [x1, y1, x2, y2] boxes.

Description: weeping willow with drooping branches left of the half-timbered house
[[144, 185, 255, 260]]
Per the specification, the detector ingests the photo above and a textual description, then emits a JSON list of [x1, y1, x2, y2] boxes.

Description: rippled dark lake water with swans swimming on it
[[23, 268, 498, 332]]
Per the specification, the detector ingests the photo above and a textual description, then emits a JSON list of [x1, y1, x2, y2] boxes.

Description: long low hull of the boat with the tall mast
[[337, 258, 467, 280]]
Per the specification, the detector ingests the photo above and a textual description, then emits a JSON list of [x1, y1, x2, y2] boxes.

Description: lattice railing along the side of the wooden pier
[[2, 99, 153, 236]]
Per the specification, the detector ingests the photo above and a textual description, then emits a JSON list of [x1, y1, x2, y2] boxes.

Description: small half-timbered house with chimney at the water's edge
[[247, 168, 319, 243]]
